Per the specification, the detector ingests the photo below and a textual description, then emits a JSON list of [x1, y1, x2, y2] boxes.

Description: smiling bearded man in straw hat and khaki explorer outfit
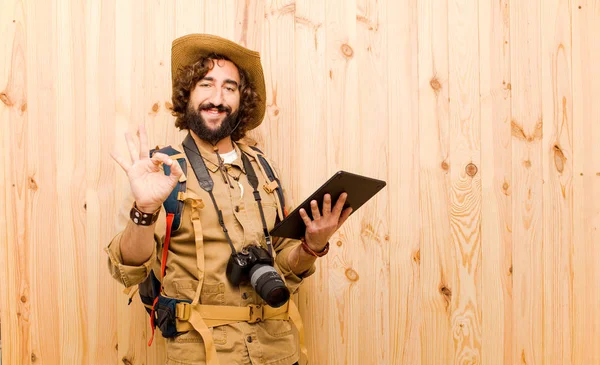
[[106, 34, 351, 365]]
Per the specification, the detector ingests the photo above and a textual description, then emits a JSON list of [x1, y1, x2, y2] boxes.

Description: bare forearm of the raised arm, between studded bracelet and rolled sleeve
[[120, 221, 156, 266]]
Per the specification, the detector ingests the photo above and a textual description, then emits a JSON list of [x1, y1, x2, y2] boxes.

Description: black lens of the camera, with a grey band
[[250, 264, 290, 308]]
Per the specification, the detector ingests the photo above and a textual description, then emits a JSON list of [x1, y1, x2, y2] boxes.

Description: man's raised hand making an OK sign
[[111, 125, 183, 213]]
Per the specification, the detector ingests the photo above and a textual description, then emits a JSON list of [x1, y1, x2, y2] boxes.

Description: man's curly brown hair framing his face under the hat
[[172, 53, 260, 141]]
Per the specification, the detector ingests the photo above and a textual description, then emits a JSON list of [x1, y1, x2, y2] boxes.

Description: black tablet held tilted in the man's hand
[[270, 171, 386, 239]]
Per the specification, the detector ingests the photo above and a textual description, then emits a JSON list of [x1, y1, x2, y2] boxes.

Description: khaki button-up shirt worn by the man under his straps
[[106, 137, 315, 365]]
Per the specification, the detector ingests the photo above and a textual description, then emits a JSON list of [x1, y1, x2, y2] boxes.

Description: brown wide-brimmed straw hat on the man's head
[[171, 34, 267, 129]]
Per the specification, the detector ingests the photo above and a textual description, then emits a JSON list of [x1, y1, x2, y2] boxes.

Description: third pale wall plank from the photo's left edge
[[55, 0, 88, 364]]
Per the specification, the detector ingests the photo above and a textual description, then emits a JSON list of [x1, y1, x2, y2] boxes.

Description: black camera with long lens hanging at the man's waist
[[227, 246, 290, 308]]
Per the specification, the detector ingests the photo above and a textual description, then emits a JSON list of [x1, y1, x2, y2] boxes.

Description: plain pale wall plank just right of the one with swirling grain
[[479, 0, 514, 365]]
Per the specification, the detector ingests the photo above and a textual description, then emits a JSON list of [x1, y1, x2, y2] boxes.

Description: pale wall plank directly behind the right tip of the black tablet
[[354, 0, 397, 364]]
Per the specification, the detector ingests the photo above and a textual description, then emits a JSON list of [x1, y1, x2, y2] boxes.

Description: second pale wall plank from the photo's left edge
[[25, 2, 62, 364]]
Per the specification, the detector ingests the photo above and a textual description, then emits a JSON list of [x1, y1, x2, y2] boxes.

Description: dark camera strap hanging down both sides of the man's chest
[[183, 133, 273, 256]]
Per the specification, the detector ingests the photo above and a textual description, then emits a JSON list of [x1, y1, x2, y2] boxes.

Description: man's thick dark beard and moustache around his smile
[[182, 103, 238, 146]]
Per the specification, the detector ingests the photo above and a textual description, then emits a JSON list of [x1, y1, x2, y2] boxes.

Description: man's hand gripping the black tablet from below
[[300, 193, 352, 252]]
